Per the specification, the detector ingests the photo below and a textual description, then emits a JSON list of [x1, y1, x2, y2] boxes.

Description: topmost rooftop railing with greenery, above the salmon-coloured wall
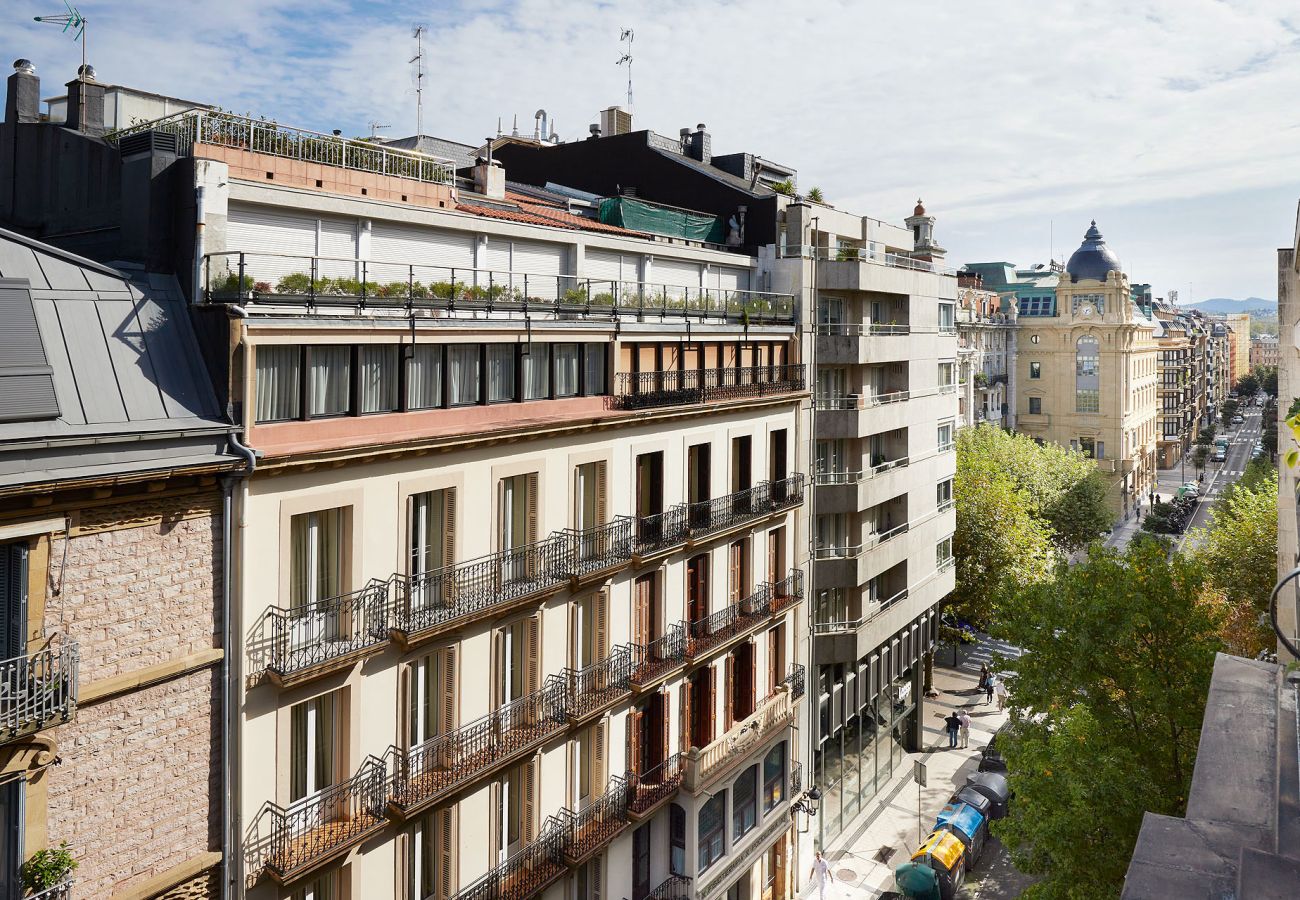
[[104, 109, 456, 185]]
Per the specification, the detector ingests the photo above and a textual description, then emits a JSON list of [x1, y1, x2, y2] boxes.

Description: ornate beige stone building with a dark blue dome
[[1013, 222, 1160, 515]]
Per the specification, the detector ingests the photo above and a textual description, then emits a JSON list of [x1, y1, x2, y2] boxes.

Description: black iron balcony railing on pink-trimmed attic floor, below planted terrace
[[614, 365, 805, 410]]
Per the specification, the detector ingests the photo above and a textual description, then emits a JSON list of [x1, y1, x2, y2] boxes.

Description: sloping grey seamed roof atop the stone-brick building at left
[[0, 229, 239, 490]]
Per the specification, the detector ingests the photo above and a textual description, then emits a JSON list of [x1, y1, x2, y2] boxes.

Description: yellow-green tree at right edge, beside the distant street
[[1192, 459, 1278, 657]]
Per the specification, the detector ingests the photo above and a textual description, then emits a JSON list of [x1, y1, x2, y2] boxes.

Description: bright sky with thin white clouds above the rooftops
[[0, 0, 1300, 302]]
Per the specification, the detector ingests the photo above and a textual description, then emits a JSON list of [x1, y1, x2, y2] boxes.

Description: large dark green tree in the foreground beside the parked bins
[[993, 538, 1223, 900]]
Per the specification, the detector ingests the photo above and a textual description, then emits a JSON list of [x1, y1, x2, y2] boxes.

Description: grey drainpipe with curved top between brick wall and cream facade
[[222, 431, 259, 900]]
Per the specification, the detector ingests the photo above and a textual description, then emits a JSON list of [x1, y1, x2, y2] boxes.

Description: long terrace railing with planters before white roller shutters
[[203, 250, 794, 325]]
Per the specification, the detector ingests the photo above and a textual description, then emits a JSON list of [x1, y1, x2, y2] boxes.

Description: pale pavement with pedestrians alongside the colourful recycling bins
[[798, 639, 1017, 900]]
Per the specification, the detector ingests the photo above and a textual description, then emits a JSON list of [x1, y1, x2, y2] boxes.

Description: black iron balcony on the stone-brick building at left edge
[[0, 640, 81, 741]]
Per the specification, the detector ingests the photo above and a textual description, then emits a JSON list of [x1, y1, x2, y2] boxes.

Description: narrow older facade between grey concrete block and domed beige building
[[957, 273, 1018, 428]]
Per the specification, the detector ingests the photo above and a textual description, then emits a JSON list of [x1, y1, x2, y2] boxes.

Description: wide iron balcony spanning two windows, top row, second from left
[[387, 533, 569, 649]]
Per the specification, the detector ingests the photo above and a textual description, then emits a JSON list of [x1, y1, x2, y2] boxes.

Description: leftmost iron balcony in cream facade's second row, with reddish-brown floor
[[267, 757, 387, 884]]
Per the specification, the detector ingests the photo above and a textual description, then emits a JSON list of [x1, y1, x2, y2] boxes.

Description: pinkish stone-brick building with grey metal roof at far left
[[0, 225, 237, 900]]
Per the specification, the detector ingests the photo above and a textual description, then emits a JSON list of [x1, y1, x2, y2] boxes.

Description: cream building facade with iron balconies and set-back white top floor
[[191, 144, 810, 900]]
